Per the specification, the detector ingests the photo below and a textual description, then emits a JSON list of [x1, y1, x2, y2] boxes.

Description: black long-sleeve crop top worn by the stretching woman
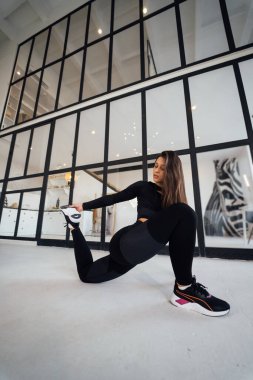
[[83, 181, 162, 219]]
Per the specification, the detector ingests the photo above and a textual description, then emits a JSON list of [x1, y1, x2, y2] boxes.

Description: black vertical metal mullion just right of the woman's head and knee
[[183, 78, 206, 256]]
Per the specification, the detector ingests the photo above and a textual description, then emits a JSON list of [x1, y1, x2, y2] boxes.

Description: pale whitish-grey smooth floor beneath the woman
[[0, 241, 253, 380]]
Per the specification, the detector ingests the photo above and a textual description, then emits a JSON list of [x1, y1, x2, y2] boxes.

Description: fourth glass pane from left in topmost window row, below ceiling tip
[[66, 7, 88, 54]]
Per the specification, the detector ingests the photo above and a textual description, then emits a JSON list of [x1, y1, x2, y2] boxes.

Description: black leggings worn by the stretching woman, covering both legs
[[72, 203, 196, 285]]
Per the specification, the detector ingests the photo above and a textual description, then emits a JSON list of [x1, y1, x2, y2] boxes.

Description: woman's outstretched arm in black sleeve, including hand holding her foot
[[70, 181, 143, 212]]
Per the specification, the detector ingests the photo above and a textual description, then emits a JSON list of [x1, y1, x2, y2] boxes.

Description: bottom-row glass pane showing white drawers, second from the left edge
[[17, 191, 40, 238]]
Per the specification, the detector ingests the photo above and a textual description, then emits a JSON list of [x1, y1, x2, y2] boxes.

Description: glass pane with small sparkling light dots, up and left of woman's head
[[109, 94, 142, 161]]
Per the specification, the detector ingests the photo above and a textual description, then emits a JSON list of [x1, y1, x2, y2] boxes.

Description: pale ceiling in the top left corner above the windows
[[0, 0, 87, 44]]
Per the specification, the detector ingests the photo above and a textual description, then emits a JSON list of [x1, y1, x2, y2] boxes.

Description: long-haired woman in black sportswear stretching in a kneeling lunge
[[62, 151, 230, 316]]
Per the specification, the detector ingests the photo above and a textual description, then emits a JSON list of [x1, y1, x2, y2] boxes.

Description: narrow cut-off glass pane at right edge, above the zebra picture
[[239, 59, 253, 127]]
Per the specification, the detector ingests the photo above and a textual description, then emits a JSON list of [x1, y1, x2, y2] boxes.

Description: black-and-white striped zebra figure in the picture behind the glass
[[204, 158, 246, 237]]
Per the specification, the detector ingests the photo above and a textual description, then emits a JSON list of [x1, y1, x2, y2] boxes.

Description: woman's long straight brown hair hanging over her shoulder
[[156, 150, 187, 207]]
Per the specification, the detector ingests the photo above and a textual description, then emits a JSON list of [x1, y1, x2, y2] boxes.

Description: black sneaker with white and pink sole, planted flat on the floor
[[170, 277, 230, 317]]
